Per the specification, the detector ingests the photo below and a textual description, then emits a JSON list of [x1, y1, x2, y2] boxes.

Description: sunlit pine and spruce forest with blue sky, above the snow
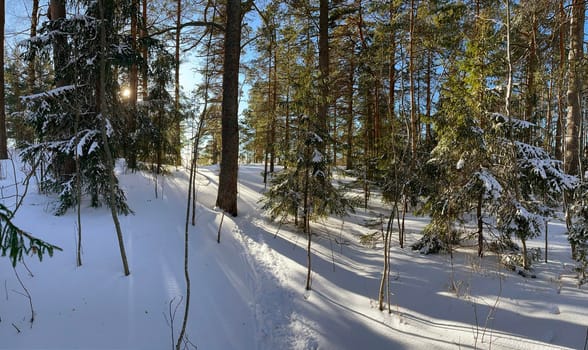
[[0, 0, 588, 326]]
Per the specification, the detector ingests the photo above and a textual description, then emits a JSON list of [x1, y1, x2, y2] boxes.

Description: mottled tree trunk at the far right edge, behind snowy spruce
[[564, 0, 586, 175]]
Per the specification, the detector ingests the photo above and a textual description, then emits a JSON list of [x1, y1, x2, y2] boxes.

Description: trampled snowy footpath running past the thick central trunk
[[195, 166, 318, 349]]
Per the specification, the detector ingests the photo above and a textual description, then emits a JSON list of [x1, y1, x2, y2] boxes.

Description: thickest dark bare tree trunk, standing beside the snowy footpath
[[216, 0, 241, 216]]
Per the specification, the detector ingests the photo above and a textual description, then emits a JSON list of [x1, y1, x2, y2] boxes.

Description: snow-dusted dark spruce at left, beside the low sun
[[21, 3, 136, 215]]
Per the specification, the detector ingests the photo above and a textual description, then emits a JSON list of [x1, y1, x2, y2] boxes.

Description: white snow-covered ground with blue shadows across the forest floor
[[0, 165, 588, 349]]
